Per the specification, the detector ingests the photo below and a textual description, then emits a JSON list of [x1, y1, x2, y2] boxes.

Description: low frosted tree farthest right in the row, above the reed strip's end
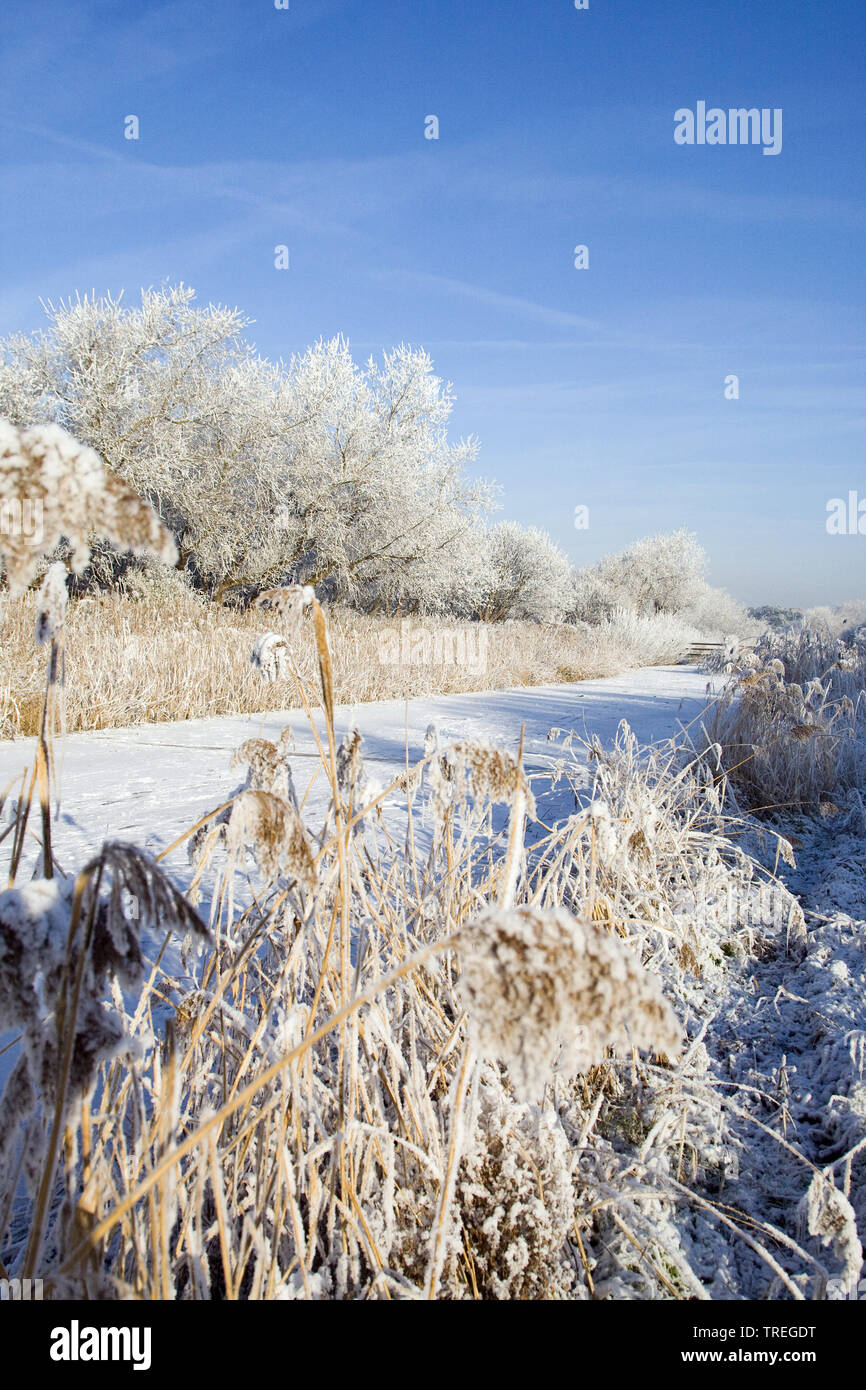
[[573, 530, 706, 623]]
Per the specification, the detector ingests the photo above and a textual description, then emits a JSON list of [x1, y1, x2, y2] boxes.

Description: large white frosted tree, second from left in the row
[[276, 338, 492, 607]]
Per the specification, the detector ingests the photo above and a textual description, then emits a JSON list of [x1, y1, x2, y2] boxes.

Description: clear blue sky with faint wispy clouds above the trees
[[0, 0, 866, 605]]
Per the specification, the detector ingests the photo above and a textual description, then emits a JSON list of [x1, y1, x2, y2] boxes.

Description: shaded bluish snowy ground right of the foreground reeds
[[650, 819, 866, 1301]]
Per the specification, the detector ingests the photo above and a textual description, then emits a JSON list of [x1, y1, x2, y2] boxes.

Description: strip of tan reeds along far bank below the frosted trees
[[0, 581, 701, 738]]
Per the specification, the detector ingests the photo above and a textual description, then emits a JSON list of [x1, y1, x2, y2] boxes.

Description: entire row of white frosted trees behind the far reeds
[[0, 285, 742, 627]]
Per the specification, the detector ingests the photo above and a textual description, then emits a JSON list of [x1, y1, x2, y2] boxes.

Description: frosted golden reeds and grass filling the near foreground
[[0, 589, 862, 1300]]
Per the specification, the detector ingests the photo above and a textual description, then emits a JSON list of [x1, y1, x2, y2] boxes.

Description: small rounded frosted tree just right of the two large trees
[[482, 521, 574, 623]]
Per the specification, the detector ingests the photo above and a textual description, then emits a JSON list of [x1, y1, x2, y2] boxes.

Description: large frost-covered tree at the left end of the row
[[0, 285, 273, 577]]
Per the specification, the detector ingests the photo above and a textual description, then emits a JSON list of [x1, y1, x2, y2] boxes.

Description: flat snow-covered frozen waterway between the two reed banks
[[0, 666, 706, 878]]
